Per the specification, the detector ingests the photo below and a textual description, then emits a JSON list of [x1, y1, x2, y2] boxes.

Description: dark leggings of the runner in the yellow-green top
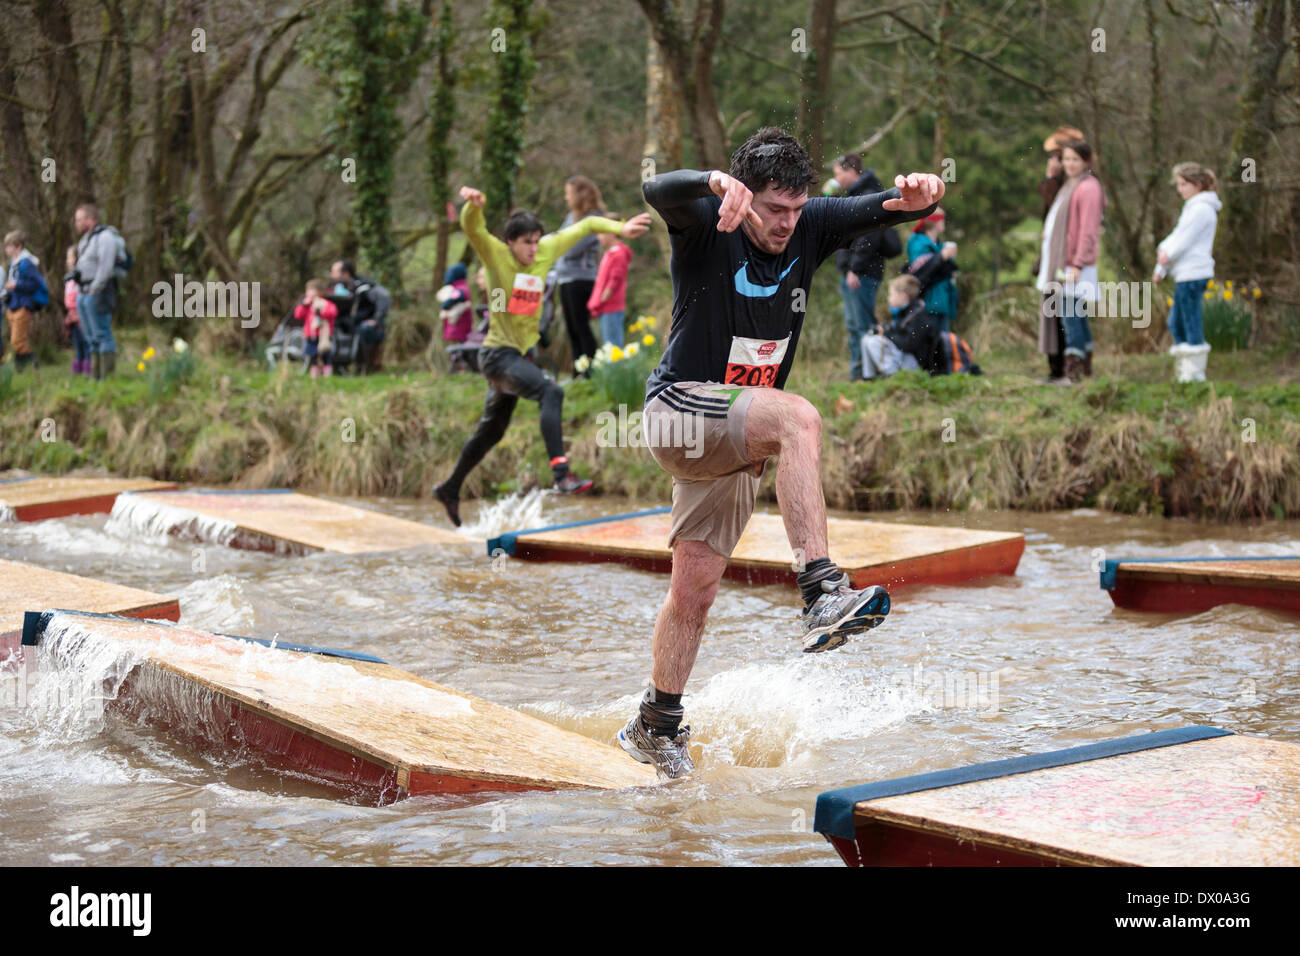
[[445, 349, 564, 494]]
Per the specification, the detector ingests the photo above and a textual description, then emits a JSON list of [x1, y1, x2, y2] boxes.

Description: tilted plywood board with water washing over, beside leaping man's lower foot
[[30, 614, 657, 795]]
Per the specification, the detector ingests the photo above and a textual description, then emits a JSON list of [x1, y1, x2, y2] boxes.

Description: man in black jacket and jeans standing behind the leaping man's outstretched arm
[[831, 152, 902, 381]]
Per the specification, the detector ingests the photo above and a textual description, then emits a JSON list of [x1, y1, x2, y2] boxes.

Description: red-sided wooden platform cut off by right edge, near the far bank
[[1101, 555, 1300, 614]]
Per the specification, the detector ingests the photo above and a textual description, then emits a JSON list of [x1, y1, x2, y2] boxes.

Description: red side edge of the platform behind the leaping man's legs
[[515, 536, 1024, 588]]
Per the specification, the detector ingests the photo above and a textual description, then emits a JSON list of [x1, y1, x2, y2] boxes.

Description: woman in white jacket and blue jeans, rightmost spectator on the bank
[[1153, 163, 1223, 353]]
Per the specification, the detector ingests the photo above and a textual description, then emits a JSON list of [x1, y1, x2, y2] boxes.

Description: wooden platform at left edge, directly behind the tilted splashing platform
[[0, 559, 181, 661]]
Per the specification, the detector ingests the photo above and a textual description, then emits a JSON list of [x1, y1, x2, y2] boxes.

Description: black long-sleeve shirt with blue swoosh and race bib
[[642, 169, 935, 401]]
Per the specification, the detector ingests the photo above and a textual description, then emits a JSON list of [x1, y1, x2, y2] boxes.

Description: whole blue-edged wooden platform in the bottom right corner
[[814, 727, 1300, 866]]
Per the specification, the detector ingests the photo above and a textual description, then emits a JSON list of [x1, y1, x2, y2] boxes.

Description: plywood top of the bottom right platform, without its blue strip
[[854, 735, 1300, 866]]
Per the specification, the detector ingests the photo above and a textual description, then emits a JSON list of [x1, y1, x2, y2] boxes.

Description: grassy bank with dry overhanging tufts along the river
[[0, 332, 1300, 519]]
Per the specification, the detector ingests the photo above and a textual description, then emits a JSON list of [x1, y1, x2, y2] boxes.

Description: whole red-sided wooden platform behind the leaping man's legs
[[488, 509, 1024, 588]]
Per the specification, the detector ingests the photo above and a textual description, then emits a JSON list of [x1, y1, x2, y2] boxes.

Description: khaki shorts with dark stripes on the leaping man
[[641, 382, 766, 558]]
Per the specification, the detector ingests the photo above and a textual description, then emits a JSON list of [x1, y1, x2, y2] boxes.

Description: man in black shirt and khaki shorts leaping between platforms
[[618, 127, 944, 777]]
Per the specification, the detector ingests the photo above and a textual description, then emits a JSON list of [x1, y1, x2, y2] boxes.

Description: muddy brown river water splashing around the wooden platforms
[[0, 493, 1300, 865]]
